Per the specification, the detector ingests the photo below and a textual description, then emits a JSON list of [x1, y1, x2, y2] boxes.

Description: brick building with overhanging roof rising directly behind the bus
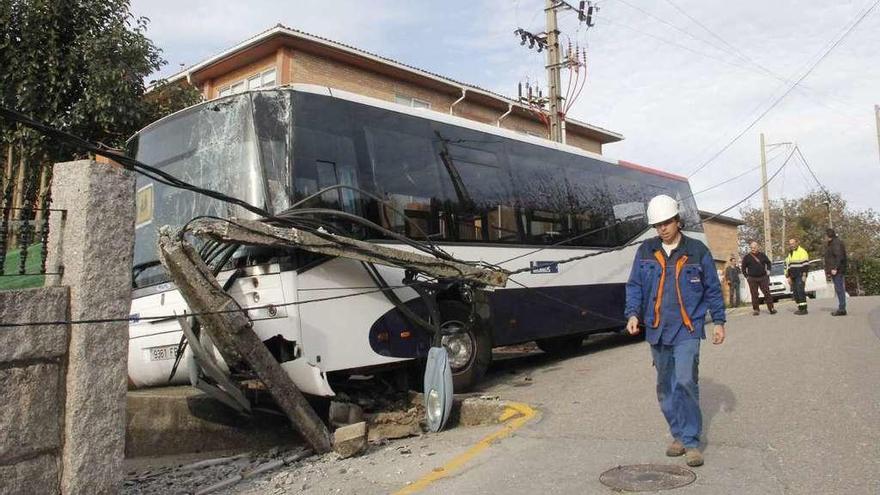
[[160, 24, 623, 153]]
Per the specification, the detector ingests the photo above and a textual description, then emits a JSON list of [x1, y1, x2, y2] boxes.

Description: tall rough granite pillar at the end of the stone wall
[[49, 160, 135, 495]]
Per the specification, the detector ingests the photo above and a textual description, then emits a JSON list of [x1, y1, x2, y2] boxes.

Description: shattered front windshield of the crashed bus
[[129, 92, 290, 287]]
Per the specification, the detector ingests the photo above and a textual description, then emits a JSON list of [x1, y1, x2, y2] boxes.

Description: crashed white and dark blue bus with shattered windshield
[[129, 85, 702, 396]]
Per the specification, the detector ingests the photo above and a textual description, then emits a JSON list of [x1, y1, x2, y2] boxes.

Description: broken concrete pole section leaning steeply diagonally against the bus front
[[159, 229, 330, 454]]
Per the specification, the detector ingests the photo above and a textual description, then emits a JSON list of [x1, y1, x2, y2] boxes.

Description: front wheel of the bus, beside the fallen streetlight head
[[439, 301, 492, 392]]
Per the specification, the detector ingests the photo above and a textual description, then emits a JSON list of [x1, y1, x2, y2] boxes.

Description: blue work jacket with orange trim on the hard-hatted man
[[626, 235, 727, 344]]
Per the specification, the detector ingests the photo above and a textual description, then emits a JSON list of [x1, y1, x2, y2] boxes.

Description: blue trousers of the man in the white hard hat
[[651, 339, 703, 448]]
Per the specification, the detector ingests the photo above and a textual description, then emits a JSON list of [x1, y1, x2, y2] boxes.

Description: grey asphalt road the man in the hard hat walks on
[[203, 297, 880, 495]]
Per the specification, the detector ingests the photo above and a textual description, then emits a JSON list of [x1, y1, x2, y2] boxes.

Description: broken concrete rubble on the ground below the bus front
[[122, 393, 509, 495]]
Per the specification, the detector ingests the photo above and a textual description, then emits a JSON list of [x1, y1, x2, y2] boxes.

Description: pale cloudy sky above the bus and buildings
[[131, 0, 880, 216]]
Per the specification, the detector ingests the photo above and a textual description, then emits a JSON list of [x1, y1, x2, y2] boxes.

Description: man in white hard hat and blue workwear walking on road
[[626, 194, 726, 466]]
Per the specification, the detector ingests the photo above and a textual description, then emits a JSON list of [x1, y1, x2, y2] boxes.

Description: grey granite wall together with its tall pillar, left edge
[[0, 161, 134, 494]]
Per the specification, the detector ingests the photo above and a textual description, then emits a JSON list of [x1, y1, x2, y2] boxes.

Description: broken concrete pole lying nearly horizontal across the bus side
[[190, 218, 508, 287]]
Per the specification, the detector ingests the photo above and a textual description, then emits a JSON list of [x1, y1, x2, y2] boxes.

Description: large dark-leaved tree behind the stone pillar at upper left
[[0, 0, 199, 250]]
